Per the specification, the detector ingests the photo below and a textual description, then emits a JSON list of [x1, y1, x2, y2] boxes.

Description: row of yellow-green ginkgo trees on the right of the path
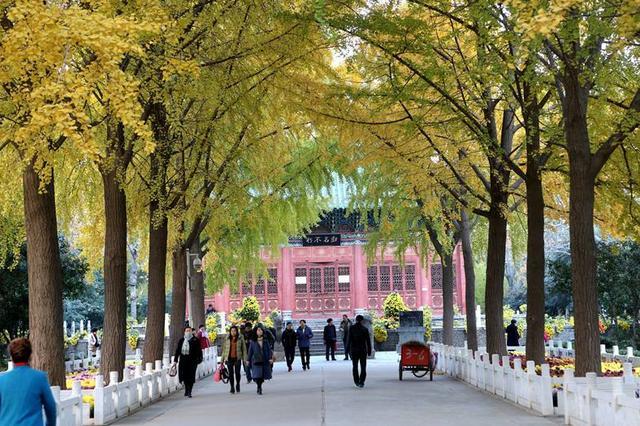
[[306, 0, 640, 375]]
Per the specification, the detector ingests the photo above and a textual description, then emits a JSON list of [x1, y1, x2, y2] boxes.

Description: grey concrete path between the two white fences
[[117, 353, 561, 426]]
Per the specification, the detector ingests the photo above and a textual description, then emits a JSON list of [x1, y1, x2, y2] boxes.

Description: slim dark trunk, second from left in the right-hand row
[[460, 209, 478, 351]]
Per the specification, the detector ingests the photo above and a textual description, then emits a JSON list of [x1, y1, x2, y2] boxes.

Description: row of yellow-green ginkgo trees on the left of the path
[[0, 0, 331, 386]]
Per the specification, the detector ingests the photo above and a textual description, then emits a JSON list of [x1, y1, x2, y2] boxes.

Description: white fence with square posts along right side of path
[[431, 343, 640, 426]]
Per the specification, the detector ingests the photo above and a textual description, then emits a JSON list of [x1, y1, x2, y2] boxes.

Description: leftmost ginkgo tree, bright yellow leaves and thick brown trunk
[[0, 0, 159, 387]]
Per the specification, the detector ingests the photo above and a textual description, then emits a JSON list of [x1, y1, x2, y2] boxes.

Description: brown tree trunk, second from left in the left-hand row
[[100, 170, 127, 380]]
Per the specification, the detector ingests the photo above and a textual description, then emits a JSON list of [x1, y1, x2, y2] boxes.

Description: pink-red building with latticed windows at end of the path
[[205, 236, 466, 319]]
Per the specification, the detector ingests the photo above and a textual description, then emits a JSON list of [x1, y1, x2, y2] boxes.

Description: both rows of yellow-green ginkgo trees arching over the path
[[0, 0, 640, 386]]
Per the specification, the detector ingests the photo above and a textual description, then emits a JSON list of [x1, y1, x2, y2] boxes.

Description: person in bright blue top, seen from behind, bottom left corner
[[0, 338, 57, 426]]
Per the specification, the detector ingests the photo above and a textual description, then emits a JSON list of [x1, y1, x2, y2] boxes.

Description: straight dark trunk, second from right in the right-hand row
[[526, 159, 545, 365]]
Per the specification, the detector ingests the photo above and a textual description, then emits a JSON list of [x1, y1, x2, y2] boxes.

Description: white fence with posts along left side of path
[[9, 347, 218, 426]]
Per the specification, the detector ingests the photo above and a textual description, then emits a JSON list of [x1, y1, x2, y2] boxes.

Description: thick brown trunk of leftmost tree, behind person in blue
[[22, 164, 66, 389]]
